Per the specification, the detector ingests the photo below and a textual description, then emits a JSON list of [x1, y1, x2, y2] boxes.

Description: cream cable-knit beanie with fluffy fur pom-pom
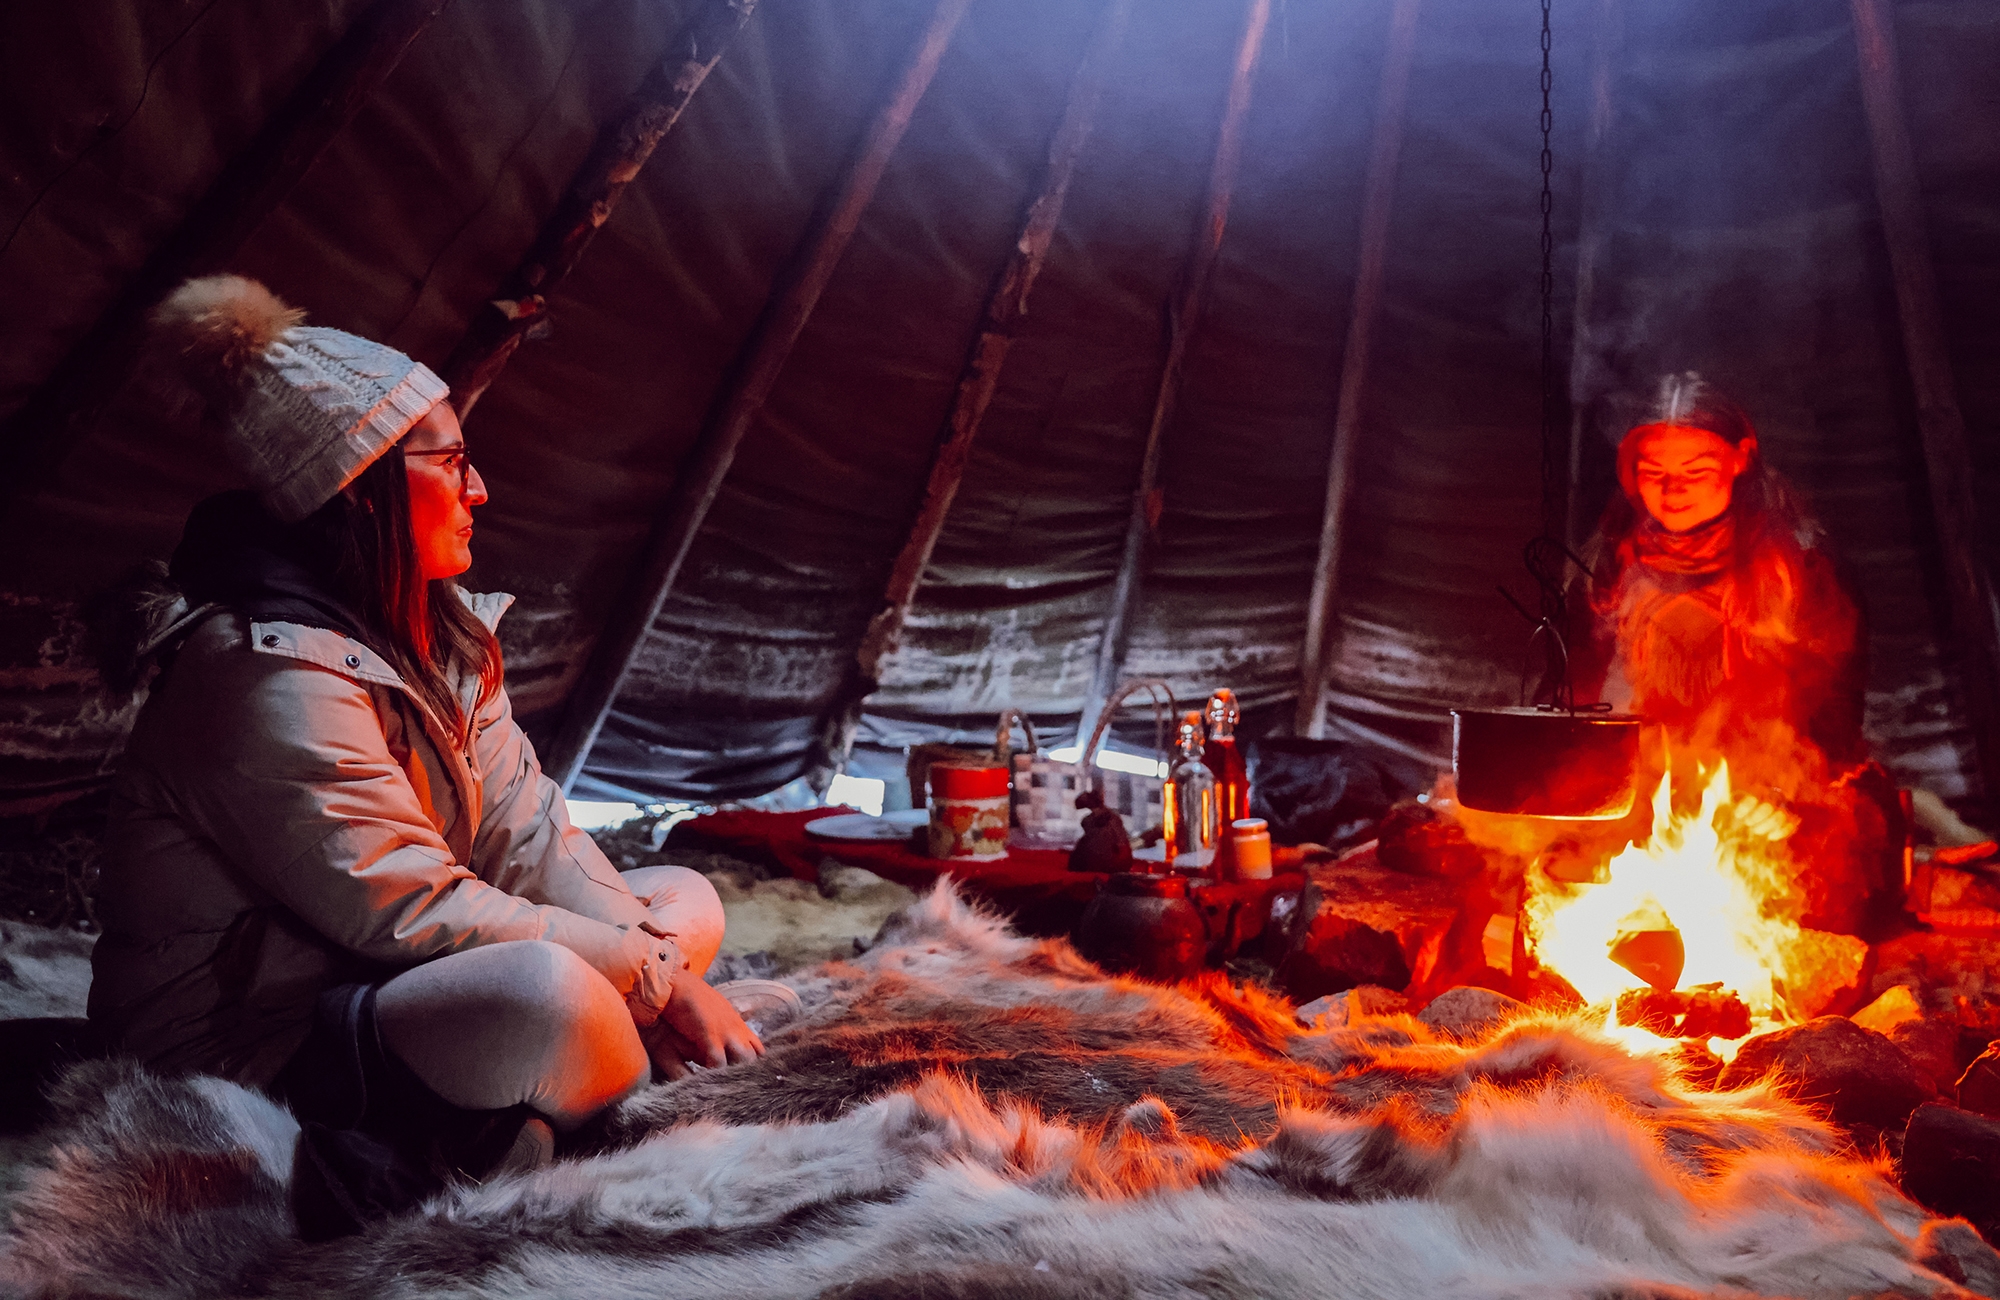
[[152, 276, 450, 520]]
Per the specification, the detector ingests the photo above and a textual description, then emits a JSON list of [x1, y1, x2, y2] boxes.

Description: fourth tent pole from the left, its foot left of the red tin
[[816, 0, 1132, 774]]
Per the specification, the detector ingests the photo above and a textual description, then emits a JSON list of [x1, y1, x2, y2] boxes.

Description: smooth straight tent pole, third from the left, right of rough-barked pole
[[544, 0, 972, 792]]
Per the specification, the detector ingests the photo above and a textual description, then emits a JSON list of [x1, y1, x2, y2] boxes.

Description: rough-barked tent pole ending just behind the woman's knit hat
[[444, 0, 756, 420]]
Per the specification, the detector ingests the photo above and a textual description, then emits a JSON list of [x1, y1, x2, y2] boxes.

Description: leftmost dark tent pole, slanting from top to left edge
[[0, 0, 450, 504]]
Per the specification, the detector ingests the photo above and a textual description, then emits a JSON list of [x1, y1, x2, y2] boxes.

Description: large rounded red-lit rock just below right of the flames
[[1716, 1016, 1936, 1130]]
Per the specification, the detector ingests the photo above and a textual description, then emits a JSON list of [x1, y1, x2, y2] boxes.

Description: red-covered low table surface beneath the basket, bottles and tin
[[666, 808, 1306, 950]]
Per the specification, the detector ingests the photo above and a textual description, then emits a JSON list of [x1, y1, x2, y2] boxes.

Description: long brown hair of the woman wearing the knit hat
[[312, 446, 502, 748]]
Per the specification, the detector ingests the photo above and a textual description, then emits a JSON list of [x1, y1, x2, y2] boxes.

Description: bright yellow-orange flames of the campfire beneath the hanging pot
[[1528, 764, 1800, 1056]]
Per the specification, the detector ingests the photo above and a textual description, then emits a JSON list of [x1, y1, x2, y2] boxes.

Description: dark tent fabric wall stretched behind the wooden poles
[[0, 0, 2000, 810]]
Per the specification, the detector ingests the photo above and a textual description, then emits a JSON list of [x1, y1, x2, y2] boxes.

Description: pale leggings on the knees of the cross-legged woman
[[376, 866, 722, 1130]]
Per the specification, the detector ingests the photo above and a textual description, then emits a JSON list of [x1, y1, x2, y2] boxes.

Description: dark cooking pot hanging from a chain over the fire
[[1452, 708, 1646, 822]]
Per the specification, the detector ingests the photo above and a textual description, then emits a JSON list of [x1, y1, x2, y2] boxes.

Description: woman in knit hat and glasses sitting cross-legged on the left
[[90, 276, 764, 1236]]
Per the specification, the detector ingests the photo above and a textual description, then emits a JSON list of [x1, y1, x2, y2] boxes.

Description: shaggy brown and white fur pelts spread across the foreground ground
[[0, 888, 2000, 1300]]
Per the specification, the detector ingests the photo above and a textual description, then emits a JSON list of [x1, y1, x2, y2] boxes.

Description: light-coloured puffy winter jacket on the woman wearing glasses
[[90, 596, 648, 1084]]
